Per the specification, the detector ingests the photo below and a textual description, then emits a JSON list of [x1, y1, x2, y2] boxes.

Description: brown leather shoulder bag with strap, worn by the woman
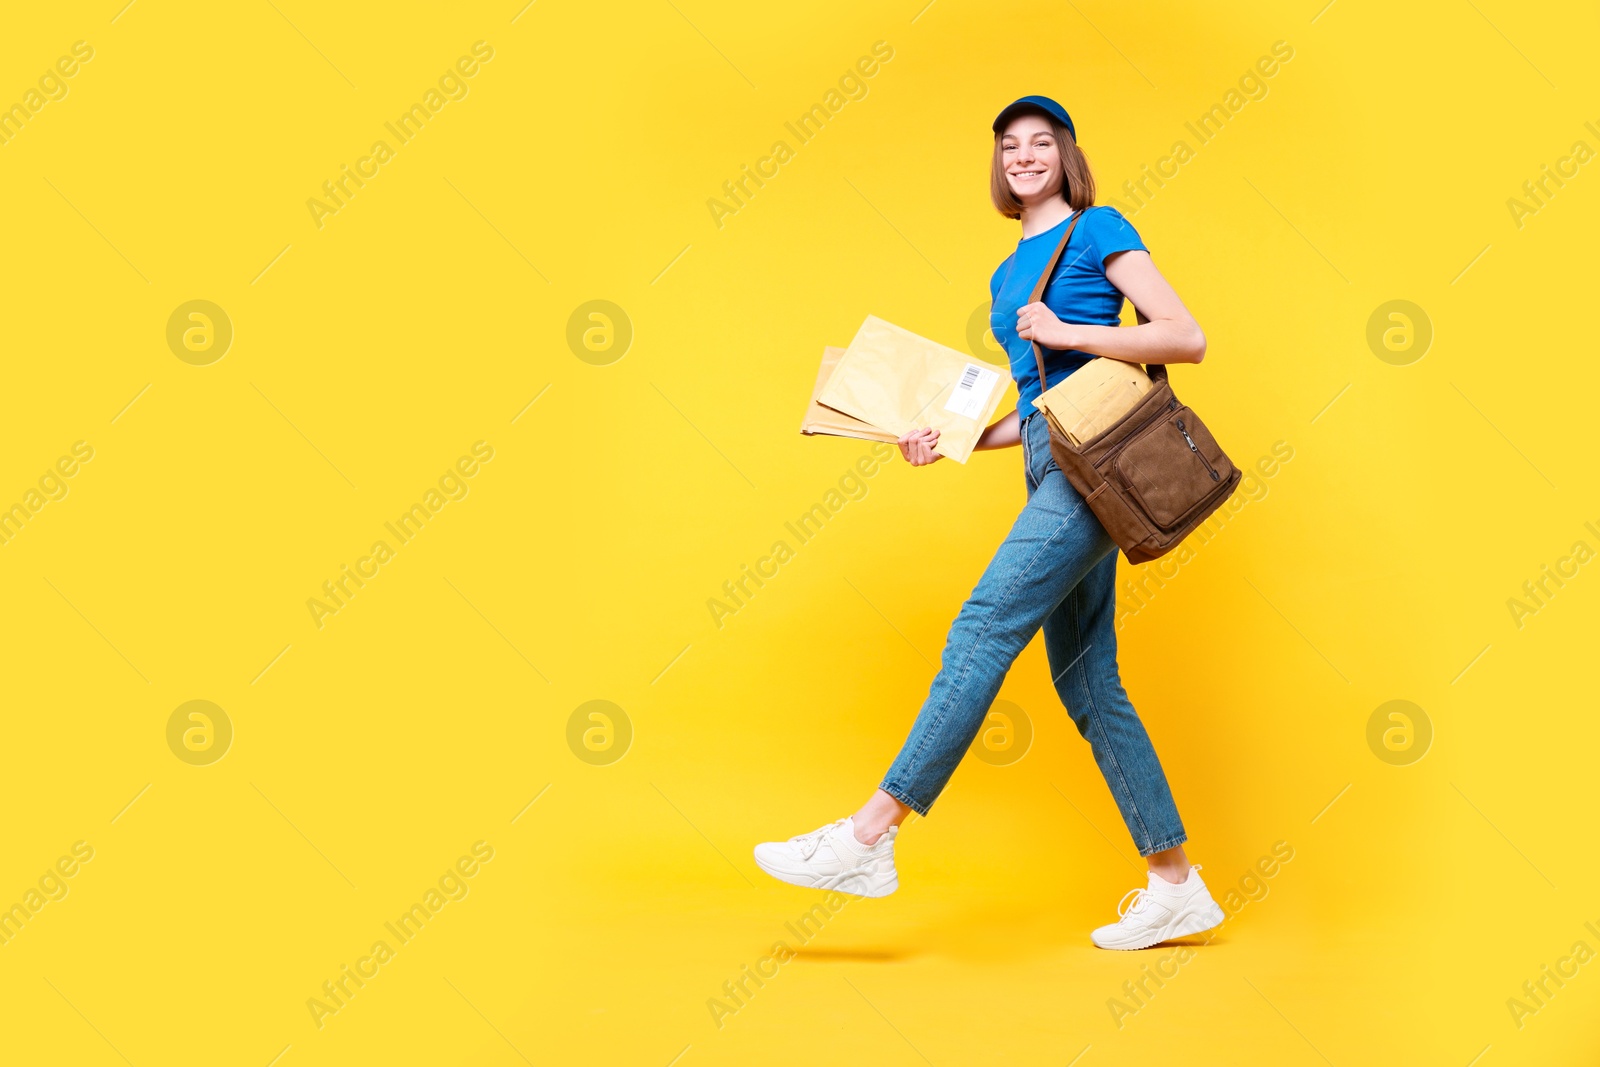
[[1029, 204, 1242, 563]]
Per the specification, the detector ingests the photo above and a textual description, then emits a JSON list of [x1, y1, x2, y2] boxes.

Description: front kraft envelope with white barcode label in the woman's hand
[[818, 315, 1011, 462]]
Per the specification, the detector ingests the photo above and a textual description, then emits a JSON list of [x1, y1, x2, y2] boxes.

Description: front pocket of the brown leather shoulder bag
[[1115, 406, 1234, 530]]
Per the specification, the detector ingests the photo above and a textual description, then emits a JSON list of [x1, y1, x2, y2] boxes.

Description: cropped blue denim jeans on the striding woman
[[880, 413, 1187, 856]]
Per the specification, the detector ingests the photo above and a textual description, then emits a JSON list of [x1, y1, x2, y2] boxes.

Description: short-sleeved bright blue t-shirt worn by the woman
[[989, 206, 1146, 419]]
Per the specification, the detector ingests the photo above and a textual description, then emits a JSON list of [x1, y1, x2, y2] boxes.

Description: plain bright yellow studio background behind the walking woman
[[0, 0, 1600, 1067]]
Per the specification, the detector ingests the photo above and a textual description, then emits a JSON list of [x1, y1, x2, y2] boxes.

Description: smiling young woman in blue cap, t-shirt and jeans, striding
[[755, 96, 1224, 949]]
